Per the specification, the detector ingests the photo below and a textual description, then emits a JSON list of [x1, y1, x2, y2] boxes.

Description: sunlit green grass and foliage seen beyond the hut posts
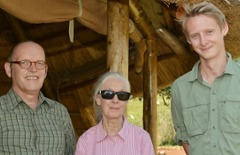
[[127, 88, 176, 146]]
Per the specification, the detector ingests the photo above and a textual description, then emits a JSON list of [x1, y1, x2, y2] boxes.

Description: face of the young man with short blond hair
[[186, 15, 228, 60]]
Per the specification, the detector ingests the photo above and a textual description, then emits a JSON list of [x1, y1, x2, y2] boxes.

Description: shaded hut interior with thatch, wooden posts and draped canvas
[[0, 0, 240, 151]]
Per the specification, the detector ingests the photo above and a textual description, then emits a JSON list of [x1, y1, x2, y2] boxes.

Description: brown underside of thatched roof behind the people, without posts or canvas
[[0, 0, 240, 138]]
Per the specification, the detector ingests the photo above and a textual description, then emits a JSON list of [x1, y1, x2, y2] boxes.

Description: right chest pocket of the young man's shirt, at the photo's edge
[[220, 95, 240, 133]]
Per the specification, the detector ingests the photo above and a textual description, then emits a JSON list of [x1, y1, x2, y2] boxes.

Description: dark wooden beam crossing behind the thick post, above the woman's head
[[52, 50, 138, 92]]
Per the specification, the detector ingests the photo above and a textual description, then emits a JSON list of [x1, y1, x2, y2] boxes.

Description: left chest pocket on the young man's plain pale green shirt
[[183, 104, 209, 137]]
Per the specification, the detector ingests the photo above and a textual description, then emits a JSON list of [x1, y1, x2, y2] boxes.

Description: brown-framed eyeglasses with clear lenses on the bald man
[[8, 60, 47, 69]]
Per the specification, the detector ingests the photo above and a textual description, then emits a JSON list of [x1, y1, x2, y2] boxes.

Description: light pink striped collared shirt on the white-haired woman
[[75, 119, 155, 155]]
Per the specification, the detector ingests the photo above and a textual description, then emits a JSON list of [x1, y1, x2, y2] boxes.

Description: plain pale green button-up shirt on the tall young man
[[171, 53, 240, 155]]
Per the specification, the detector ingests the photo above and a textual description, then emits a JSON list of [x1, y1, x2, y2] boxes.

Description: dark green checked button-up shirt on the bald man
[[0, 89, 76, 155]]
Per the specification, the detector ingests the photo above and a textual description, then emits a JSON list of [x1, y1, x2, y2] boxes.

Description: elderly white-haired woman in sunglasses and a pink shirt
[[75, 72, 155, 155]]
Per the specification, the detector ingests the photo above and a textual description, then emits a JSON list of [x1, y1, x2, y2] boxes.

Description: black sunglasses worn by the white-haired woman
[[99, 90, 131, 101]]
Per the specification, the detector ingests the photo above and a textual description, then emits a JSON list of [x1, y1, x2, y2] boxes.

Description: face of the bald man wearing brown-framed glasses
[[5, 42, 47, 94]]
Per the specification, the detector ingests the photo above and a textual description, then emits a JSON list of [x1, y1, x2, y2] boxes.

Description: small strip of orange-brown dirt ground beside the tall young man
[[157, 147, 186, 155]]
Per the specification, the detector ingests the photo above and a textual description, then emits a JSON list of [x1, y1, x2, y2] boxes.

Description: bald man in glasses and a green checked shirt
[[0, 41, 75, 155]]
